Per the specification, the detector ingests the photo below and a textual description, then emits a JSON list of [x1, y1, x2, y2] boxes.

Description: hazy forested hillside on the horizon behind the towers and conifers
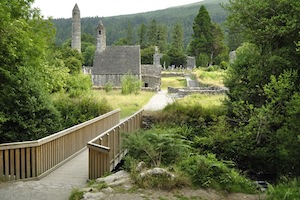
[[53, 0, 228, 45]]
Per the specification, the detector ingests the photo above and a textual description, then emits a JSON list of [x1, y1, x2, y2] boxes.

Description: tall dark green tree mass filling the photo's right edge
[[225, 0, 300, 176]]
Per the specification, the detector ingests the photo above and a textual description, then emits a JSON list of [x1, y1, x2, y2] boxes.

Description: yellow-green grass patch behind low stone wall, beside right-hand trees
[[194, 69, 225, 87]]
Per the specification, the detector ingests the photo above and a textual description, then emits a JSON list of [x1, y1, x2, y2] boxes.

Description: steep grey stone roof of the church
[[92, 46, 141, 75]]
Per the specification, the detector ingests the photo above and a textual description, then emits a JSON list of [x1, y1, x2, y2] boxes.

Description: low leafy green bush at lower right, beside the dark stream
[[180, 154, 256, 193]]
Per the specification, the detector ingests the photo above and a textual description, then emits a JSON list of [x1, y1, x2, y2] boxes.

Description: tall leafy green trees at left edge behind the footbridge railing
[[0, 0, 60, 143]]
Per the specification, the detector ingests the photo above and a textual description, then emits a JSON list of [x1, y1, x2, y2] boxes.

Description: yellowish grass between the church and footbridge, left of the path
[[94, 90, 155, 118]]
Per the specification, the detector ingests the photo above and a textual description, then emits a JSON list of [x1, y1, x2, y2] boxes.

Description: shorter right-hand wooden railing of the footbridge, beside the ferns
[[87, 110, 143, 179]]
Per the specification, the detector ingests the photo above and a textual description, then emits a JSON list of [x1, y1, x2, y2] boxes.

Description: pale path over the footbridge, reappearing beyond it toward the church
[[0, 91, 173, 200]]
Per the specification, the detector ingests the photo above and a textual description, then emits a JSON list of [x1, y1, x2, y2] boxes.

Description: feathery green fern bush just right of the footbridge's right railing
[[124, 127, 190, 166]]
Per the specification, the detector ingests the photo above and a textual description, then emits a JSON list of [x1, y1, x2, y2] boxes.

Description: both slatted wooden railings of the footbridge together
[[0, 109, 143, 180]]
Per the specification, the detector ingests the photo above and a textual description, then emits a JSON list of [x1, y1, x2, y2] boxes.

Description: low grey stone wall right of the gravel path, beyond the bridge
[[168, 86, 228, 97]]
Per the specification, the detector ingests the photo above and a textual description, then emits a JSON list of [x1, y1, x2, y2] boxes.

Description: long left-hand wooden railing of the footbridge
[[0, 109, 120, 180]]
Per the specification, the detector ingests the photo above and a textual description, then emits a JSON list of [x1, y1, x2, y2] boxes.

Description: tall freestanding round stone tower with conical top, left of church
[[72, 4, 81, 52]]
